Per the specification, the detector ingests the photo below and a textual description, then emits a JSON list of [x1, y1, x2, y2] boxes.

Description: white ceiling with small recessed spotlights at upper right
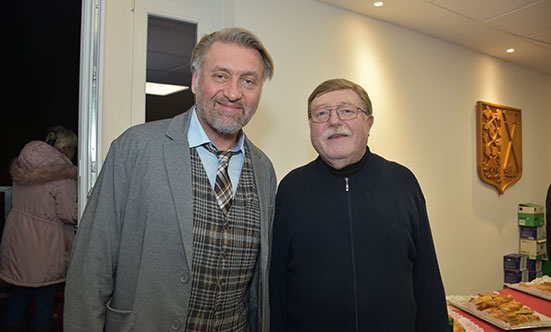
[[317, 0, 551, 75]]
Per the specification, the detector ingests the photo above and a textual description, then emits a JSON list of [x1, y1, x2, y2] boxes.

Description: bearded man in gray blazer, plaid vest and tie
[[64, 28, 276, 332]]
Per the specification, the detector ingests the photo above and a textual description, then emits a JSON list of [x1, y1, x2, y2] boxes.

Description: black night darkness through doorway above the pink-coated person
[[0, 0, 81, 186]]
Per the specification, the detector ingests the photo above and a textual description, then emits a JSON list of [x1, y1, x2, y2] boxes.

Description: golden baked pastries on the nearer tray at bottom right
[[469, 292, 540, 326]]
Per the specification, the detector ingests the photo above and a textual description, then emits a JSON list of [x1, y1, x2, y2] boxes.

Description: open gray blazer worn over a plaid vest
[[64, 111, 277, 332]]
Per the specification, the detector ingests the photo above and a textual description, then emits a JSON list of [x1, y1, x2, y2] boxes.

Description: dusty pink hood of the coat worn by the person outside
[[10, 141, 78, 184]]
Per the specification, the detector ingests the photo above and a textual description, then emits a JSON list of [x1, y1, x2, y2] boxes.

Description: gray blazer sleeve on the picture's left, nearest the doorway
[[63, 140, 128, 332]]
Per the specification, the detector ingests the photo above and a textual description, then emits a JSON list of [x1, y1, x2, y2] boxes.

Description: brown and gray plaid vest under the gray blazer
[[186, 149, 260, 332]]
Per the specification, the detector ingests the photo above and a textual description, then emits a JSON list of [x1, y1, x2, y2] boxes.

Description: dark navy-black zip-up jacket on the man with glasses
[[270, 148, 448, 332]]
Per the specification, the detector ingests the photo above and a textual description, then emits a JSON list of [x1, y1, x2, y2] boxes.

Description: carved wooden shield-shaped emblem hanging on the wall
[[476, 101, 522, 194]]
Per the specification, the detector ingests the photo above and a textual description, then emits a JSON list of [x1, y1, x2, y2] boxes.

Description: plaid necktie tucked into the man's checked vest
[[203, 143, 235, 215]]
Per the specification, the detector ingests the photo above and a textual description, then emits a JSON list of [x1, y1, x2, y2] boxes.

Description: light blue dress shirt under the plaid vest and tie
[[187, 106, 245, 196]]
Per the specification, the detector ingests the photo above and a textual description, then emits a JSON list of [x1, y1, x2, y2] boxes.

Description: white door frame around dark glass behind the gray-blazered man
[[78, 0, 224, 219]]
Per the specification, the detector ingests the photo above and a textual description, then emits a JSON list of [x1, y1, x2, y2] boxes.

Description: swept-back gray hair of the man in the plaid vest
[[191, 28, 274, 80]]
